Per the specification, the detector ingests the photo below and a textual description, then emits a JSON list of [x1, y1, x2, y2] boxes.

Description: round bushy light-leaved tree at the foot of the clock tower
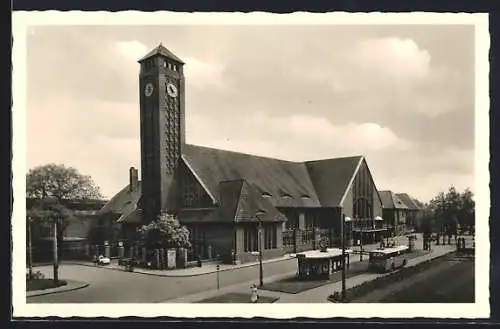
[[139, 213, 191, 249]]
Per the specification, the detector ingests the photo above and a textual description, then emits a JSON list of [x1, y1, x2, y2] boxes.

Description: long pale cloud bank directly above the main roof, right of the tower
[[187, 112, 410, 161]]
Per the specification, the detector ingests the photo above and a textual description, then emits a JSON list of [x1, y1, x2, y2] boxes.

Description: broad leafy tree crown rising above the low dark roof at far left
[[26, 163, 102, 200]]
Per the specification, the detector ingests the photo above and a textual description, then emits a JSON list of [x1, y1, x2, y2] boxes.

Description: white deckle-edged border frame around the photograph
[[12, 11, 490, 319]]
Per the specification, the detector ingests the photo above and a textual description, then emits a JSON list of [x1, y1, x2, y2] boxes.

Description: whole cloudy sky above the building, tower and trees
[[27, 25, 475, 202]]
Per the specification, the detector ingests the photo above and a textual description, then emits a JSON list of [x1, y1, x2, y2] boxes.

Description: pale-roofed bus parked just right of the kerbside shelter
[[369, 246, 408, 272]]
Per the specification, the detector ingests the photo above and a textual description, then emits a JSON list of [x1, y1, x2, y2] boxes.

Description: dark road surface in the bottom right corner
[[353, 251, 475, 303]]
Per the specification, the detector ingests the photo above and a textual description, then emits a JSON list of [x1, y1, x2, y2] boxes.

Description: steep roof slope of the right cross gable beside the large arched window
[[305, 156, 363, 207]]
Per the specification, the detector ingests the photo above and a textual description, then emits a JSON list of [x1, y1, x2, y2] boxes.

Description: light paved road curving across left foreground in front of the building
[[27, 259, 297, 303]]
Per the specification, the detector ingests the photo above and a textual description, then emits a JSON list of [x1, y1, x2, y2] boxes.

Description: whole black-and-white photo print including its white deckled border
[[12, 12, 489, 318]]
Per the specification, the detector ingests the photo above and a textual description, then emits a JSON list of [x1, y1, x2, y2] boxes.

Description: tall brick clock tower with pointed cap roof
[[139, 44, 185, 222]]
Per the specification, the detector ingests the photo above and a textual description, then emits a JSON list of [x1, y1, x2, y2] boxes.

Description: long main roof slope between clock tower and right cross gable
[[183, 144, 320, 207]]
